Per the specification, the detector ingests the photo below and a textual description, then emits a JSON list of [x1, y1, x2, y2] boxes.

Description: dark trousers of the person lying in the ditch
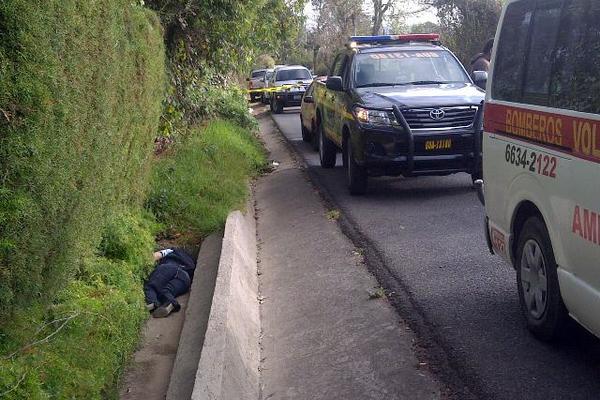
[[144, 263, 191, 311]]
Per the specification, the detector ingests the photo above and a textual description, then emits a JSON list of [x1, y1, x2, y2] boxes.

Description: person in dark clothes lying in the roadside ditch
[[144, 249, 196, 318]]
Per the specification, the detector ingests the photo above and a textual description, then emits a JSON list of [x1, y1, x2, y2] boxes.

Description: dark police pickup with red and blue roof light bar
[[313, 34, 485, 195]]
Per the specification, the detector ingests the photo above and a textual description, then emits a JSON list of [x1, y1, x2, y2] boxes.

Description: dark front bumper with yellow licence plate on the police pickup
[[357, 104, 482, 176]]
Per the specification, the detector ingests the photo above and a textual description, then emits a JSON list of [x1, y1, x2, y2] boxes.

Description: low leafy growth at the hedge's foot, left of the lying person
[[0, 213, 157, 400]]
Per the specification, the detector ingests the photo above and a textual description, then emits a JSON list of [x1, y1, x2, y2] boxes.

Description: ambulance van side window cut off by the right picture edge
[[550, 0, 600, 114]]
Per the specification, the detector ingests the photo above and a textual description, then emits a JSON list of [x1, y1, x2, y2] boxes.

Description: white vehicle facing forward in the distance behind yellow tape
[[269, 65, 312, 114]]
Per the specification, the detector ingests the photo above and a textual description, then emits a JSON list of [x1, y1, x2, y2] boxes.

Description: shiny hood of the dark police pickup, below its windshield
[[355, 83, 485, 108]]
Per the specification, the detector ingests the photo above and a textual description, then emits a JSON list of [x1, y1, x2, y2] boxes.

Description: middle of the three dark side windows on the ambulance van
[[523, 1, 562, 106]]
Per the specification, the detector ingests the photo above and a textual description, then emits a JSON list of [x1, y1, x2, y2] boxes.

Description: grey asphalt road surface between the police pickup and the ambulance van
[[273, 105, 600, 400]]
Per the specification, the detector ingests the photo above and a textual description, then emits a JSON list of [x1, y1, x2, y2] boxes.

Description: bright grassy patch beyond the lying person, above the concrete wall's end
[[147, 121, 265, 236]]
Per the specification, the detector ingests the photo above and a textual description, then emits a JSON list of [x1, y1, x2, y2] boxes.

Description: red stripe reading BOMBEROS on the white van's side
[[484, 103, 600, 163]]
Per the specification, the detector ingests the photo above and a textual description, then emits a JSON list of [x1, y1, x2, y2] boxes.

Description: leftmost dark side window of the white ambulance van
[[492, 1, 535, 102]]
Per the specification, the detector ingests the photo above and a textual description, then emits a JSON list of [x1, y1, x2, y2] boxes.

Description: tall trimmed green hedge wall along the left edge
[[0, 0, 165, 318]]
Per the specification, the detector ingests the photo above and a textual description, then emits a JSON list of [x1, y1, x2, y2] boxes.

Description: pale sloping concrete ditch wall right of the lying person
[[192, 207, 260, 400]]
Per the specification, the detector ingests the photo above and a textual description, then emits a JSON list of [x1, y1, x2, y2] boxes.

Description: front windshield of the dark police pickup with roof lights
[[354, 50, 470, 88]]
